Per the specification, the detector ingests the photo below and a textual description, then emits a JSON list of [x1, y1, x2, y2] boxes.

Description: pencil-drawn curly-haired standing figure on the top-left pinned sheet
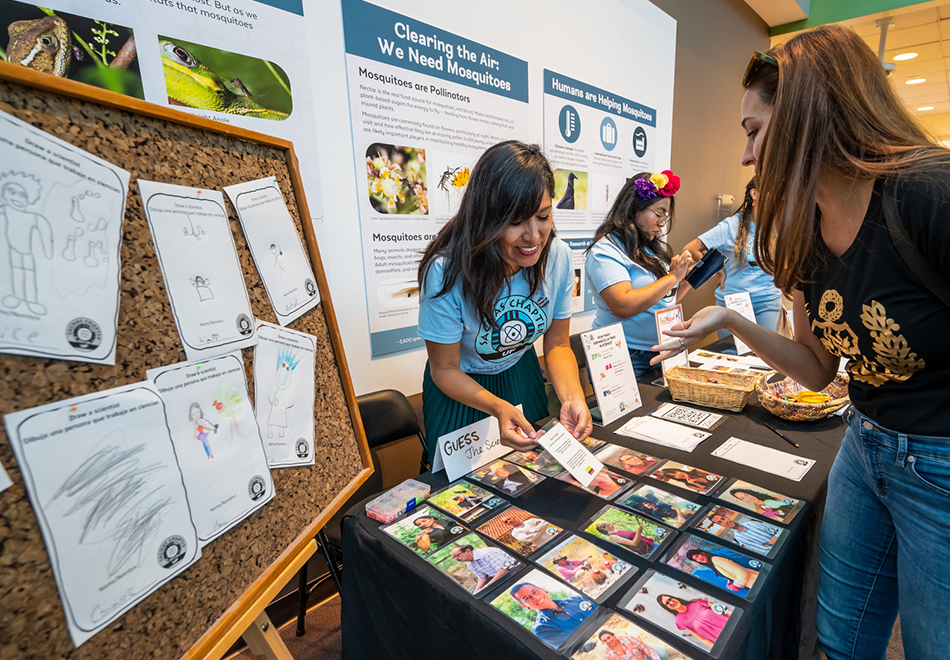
[[0, 172, 53, 316]]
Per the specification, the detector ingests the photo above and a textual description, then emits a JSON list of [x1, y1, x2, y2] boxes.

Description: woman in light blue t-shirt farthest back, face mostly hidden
[[686, 178, 782, 337]]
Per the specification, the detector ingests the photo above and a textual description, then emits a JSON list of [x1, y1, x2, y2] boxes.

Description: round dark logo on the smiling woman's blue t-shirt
[[475, 296, 548, 362]]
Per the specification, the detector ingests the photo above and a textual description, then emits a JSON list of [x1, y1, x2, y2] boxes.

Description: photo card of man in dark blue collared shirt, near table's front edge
[[485, 568, 597, 649]]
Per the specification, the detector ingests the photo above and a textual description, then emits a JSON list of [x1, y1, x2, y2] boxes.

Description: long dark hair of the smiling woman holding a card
[[418, 140, 554, 327]]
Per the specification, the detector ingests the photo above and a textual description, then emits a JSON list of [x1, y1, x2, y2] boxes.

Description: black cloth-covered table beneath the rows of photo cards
[[342, 368, 845, 660]]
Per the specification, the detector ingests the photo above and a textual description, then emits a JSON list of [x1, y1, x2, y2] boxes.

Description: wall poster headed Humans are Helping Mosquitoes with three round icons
[[544, 69, 656, 230]]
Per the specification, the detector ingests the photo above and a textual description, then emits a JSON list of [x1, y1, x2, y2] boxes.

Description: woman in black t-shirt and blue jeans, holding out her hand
[[653, 27, 950, 660]]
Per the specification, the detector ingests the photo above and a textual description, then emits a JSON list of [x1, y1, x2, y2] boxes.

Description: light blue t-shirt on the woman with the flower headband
[[584, 236, 676, 351]]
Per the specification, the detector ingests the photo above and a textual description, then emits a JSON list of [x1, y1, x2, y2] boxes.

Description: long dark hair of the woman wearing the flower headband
[[587, 172, 676, 279]]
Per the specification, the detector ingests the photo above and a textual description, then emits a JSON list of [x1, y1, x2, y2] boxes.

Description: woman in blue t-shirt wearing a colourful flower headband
[[585, 170, 693, 375]]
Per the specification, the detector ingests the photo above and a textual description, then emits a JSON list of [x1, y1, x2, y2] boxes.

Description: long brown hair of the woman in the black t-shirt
[[746, 26, 950, 294]]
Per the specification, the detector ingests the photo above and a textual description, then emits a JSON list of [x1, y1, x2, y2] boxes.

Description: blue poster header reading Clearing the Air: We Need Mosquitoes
[[343, 0, 528, 103]]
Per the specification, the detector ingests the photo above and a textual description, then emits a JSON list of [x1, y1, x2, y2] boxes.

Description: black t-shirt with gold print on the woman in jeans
[[801, 169, 950, 436]]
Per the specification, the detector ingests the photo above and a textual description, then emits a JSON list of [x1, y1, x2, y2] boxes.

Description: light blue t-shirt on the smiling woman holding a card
[[419, 238, 574, 374]]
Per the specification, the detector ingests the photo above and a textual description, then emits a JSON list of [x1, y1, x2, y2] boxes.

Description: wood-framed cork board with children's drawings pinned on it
[[0, 64, 372, 660]]
